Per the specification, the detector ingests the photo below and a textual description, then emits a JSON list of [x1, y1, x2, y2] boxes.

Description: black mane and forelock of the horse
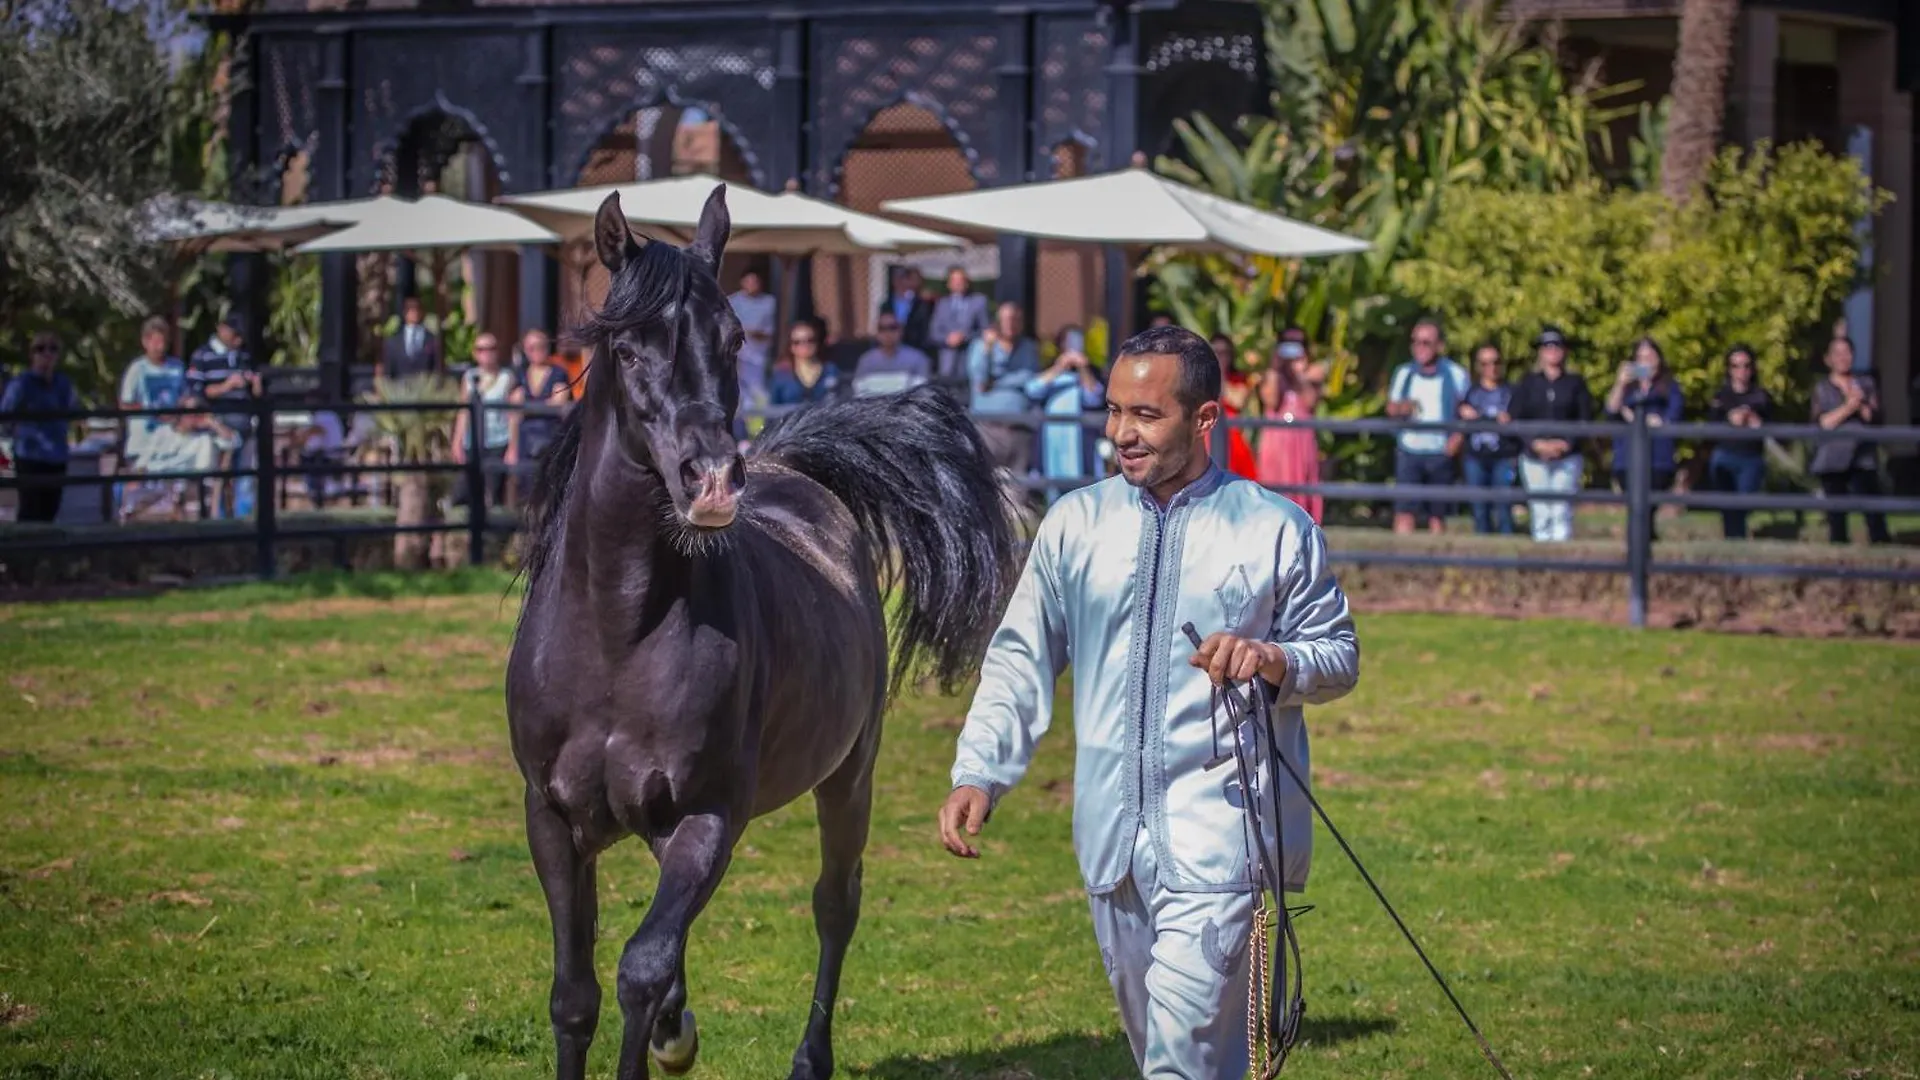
[[520, 240, 703, 586]]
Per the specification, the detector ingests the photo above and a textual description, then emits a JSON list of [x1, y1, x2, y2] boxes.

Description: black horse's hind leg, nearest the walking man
[[791, 724, 879, 1080]]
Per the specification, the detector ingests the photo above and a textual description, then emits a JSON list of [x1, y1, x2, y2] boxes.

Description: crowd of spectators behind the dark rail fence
[[0, 276, 1889, 544]]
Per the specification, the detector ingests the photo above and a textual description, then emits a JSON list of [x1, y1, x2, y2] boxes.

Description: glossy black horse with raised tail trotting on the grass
[[507, 186, 1018, 1080]]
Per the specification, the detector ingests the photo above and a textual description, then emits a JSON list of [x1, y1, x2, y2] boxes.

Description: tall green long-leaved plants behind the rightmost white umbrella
[[1156, 0, 1615, 374]]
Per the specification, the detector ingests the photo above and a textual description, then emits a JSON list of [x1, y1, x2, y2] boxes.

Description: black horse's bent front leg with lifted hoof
[[618, 813, 733, 1080]]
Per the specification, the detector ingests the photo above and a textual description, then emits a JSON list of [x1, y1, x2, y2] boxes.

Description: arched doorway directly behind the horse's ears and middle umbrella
[[561, 104, 766, 327]]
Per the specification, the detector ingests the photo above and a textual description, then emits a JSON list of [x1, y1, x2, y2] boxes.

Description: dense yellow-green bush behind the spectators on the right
[[1396, 144, 1889, 407]]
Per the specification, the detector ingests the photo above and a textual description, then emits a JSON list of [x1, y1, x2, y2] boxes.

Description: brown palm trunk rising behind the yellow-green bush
[[1661, 0, 1740, 204]]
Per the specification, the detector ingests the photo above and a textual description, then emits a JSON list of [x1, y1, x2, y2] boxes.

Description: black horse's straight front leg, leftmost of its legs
[[526, 788, 601, 1080]]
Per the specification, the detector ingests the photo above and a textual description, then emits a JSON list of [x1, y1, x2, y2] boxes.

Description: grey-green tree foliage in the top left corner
[[0, 0, 225, 386]]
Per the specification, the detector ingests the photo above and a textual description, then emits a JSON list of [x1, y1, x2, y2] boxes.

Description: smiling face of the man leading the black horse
[[1106, 356, 1219, 490]]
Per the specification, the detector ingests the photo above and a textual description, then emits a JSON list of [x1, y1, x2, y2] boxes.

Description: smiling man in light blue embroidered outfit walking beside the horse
[[939, 327, 1359, 1080]]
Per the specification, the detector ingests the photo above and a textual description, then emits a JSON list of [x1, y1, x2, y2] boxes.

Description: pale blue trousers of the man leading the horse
[[1089, 828, 1254, 1080]]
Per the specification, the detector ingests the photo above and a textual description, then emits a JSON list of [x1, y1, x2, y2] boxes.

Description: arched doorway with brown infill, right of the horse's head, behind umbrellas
[[812, 100, 998, 361]]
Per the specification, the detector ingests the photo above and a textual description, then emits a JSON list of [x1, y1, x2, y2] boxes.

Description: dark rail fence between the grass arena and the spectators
[[0, 398, 1920, 626]]
